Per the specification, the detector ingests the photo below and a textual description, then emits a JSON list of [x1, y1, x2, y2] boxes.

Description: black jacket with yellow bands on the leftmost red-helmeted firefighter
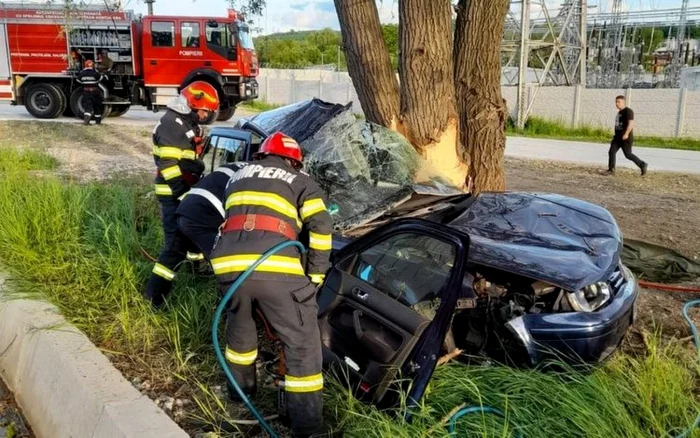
[[153, 108, 204, 199]]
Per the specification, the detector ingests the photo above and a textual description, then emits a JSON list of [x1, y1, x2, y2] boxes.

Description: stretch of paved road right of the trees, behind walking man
[[506, 137, 700, 174]]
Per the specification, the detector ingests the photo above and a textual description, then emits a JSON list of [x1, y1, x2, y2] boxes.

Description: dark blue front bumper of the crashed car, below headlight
[[506, 266, 639, 365]]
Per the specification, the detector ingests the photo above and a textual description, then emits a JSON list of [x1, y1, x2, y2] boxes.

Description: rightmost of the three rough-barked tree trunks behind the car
[[454, 0, 510, 193]]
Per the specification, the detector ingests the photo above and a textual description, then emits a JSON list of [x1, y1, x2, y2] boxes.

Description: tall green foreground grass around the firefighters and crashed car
[[0, 148, 700, 438]]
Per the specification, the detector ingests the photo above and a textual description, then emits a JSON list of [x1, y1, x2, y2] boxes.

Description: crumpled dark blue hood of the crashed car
[[449, 193, 622, 290]]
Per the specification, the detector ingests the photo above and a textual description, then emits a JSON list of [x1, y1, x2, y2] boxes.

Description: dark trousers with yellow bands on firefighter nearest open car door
[[219, 274, 323, 436]]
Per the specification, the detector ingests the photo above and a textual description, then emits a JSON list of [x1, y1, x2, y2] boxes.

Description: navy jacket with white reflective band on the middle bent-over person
[[177, 162, 248, 232]]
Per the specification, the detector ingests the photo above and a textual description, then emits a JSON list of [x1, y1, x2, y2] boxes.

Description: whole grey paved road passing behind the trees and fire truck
[[0, 104, 700, 174]]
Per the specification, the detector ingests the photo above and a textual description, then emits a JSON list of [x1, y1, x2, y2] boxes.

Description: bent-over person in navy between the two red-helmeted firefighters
[[176, 162, 248, 260]]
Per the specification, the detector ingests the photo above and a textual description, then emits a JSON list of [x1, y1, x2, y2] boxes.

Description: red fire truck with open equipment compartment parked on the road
[[0, 2, 258, 123]]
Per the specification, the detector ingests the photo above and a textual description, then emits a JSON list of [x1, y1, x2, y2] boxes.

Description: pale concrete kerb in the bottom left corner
[[0, 272, 188, 438]]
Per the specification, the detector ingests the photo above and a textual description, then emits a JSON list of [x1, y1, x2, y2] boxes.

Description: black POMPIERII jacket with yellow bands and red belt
[[211, 155, 332, 282]]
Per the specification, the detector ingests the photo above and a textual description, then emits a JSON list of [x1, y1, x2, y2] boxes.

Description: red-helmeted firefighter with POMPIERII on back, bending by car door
[[211, 132, 332, 437]]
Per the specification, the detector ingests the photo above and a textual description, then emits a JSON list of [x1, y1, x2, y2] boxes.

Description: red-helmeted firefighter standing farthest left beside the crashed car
[[144, 81, 219, 308]]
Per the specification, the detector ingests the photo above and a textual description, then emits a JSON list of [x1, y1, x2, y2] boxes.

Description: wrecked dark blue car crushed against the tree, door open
[[208, 100, 638, 404]]
